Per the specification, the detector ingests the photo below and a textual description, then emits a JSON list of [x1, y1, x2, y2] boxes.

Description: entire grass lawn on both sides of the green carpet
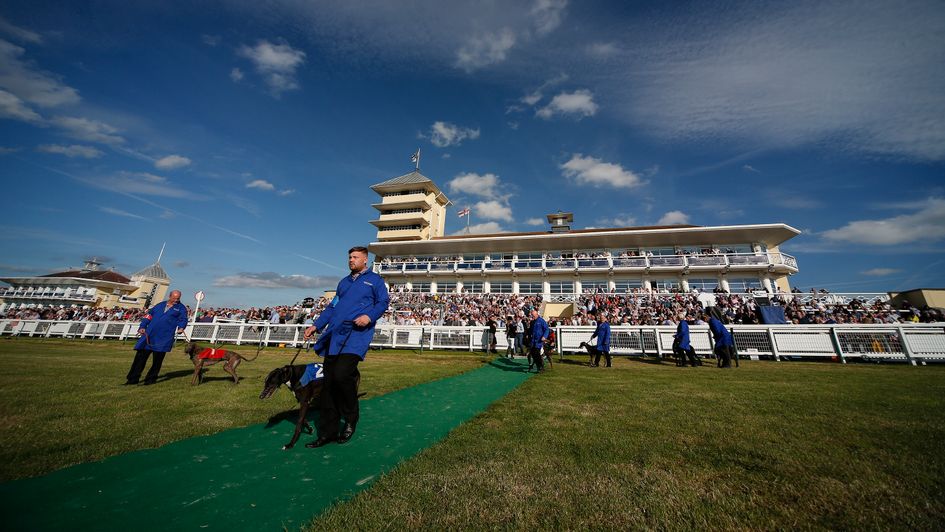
[[0, 339, 945, 529]]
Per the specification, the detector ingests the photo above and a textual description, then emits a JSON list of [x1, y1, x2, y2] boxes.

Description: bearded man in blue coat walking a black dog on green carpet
[[305, 246, 390, 448]]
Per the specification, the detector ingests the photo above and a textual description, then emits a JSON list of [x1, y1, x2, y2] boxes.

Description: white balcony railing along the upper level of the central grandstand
[[374, 253, 797, 275]]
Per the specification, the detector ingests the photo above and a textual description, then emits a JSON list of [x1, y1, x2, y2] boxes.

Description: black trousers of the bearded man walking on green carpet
[[318, 354, 361, 438]]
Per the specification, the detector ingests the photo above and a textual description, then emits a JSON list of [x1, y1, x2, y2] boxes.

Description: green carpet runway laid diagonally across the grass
[[0, 358, 529, 530]]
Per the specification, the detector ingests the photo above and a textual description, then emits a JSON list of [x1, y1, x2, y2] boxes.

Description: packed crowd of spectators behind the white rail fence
[[0, 289, 945, 327]]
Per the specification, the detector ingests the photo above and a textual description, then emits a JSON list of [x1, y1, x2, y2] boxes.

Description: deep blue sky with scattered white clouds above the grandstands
[[0, 0, 945, 306]]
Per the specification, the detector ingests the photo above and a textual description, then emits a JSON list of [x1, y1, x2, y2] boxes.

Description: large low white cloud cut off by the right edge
[[823, 198, 945, 246]]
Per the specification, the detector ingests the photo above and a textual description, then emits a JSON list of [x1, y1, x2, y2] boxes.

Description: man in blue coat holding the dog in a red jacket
[[125, 290, 187, 385]]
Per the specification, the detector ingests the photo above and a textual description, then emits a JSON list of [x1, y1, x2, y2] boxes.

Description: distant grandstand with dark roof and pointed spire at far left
[[0, 257, 171, 309]]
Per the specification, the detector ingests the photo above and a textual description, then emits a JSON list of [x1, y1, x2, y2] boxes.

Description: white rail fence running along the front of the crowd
[[0, 320, 945, 364]]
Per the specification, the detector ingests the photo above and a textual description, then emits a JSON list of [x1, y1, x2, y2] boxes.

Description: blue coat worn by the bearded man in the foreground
[[314, 270, 390, 360]]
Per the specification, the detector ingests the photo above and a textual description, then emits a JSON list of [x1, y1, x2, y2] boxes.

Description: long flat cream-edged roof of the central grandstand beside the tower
[[370, 223, 800, 257]]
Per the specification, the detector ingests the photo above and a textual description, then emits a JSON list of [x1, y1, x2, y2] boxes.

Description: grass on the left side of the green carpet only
[[0, 338, 491, 481]]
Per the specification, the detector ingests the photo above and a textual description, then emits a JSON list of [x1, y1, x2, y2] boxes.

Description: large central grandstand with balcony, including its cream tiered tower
[[369, 172, 800, 302]]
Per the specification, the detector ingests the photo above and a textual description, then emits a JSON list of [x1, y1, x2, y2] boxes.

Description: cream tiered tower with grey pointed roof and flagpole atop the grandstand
[[371, 171, 452, 242]]
